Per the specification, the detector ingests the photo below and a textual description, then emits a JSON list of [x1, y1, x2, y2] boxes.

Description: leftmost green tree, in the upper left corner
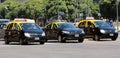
[[0, 0, 20, 18]]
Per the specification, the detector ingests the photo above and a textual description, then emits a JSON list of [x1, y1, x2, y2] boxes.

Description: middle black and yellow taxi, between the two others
[[45, 22, 85, 42]]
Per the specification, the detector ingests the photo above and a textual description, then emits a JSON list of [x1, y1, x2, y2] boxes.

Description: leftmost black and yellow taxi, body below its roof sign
[[4, 18, 45, 45]]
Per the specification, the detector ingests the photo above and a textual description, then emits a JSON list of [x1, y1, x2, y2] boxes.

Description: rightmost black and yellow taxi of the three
[[77, 20, 118, 41]]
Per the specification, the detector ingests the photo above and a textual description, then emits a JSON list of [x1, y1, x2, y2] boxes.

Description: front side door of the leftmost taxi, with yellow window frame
[[12, 23, 20, 41]]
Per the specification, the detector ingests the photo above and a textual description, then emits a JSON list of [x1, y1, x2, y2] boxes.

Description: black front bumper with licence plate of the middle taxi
[[62, 34, 85, 40]]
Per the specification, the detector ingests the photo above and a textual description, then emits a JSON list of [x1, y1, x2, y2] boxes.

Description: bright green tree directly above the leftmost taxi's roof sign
[[18, 0, 44, 19]]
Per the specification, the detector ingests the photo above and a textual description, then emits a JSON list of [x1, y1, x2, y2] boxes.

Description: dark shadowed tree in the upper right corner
[[100, 0, 120, 19]]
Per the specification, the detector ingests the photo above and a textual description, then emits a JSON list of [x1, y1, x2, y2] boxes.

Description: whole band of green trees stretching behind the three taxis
[[0, 0, 120, 20]]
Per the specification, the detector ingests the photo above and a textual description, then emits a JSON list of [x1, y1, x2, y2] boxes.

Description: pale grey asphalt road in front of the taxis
[[0, 32, 120, 58]]
